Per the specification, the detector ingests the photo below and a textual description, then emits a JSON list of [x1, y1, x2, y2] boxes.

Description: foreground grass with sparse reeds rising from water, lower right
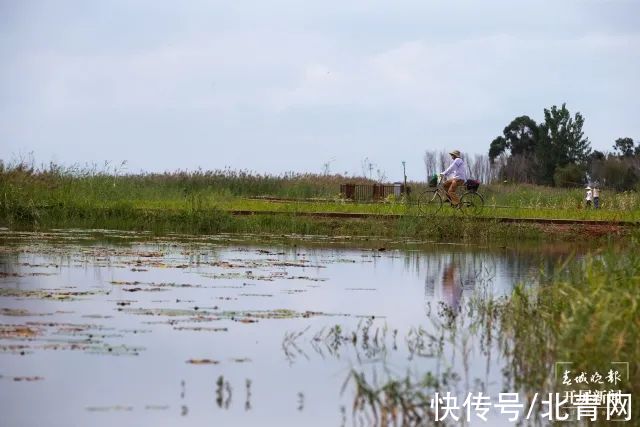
[[350, 236, 640, 426]]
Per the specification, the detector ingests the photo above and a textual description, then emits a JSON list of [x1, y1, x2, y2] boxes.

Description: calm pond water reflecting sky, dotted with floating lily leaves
[[0, 230, 580, 426]]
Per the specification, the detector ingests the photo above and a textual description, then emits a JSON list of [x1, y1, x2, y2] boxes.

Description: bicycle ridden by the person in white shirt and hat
[[416, 176, 484, 216]]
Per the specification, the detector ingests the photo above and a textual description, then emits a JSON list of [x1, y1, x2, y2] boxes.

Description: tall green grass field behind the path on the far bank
[[0, 158, 640, 234]]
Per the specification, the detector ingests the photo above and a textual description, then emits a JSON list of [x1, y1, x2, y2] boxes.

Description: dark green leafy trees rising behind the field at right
[[488, 104, 640, 190]]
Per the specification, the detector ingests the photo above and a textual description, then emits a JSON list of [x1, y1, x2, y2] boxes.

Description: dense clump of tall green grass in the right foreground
[[500, 246, 640, 397]]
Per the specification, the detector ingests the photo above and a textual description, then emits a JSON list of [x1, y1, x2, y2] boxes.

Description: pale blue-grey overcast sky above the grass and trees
[[0, 0, 640, 181]]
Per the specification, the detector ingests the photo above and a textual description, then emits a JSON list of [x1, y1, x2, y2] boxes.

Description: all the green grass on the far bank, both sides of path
[[0, 162, 640, 240]]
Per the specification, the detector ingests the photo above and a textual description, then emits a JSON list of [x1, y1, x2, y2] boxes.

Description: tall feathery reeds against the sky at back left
[[0, 162, 373, 201]]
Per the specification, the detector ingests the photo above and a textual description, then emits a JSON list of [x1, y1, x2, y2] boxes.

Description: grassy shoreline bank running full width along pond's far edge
[[0, 204, 640, 243]]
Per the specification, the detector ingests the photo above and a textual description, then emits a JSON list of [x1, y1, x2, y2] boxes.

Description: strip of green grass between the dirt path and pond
[[0, 204, 543, 242]]
